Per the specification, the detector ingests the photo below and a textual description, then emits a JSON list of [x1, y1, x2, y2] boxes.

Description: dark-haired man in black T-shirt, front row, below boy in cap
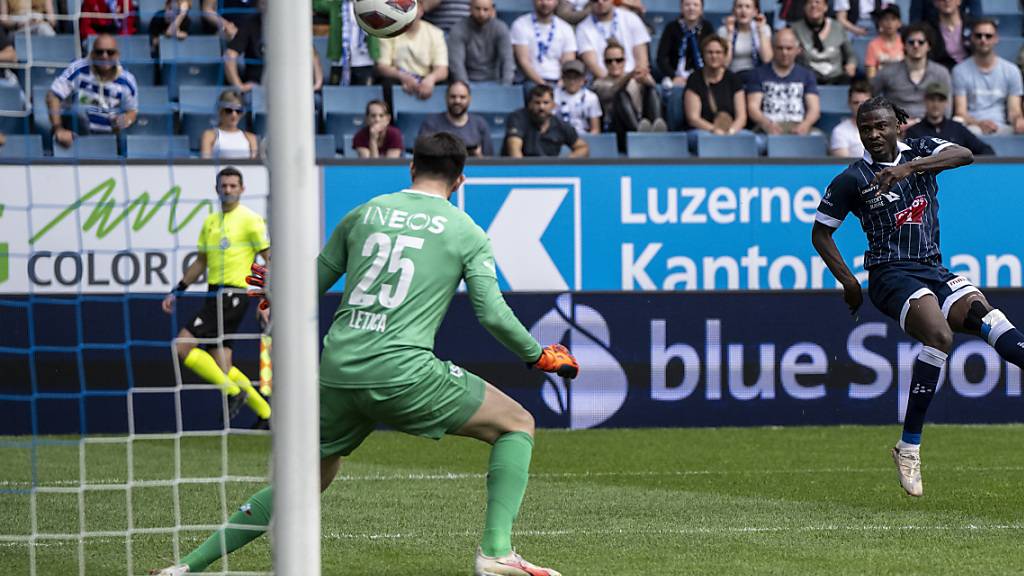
[[505, 85, 590, 158]]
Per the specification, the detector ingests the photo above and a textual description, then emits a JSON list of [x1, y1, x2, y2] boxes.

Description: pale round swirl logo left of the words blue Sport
[[529, 294, 629, 428]]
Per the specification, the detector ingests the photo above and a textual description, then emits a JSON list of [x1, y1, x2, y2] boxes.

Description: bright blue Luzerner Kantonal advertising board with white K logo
[[324, 164, 1024, 291]]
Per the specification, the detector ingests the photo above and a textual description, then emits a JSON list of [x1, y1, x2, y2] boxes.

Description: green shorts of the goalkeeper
[[319, 358, 485, 458]]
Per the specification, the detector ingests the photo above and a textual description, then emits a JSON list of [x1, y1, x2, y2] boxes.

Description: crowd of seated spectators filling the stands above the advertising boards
[[0, 0, 1024, 158]]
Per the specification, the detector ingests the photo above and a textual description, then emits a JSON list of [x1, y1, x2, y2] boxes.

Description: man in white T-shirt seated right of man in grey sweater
[[510, 0, 577, 86]]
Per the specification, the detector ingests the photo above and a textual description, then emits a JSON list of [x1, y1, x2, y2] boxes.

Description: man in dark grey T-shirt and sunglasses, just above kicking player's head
[[871, 24, 952, 124]]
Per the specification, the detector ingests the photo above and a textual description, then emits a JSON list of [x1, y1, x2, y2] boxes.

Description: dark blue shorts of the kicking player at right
[[867, 260, 979, 330]]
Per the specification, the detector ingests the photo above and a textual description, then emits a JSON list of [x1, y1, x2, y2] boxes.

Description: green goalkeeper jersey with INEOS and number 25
[[316, 190, 541, 387]]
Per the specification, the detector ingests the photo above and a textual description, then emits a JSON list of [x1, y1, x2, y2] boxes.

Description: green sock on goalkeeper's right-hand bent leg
[[480, 431, 534, 558]]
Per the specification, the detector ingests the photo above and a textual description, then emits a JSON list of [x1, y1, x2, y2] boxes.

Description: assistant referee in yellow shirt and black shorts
[[163, 166, 270, 420]]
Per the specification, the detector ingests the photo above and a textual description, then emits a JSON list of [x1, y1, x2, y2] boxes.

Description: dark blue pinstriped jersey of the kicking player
[[815, 138, 953, 270]]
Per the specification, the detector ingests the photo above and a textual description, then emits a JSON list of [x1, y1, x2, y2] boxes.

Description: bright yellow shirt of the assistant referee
[[199, 204, 270, 288]]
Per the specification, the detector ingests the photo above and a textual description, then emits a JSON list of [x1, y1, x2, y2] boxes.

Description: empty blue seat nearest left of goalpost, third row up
[[160, 36, 224, 98]]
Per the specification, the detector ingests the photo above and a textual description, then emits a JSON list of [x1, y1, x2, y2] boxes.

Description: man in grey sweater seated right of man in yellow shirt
[[447, 0, 515, 85]]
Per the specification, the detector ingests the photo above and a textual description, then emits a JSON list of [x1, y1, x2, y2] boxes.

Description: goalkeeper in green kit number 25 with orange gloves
[[160, 132, 579, 576]]
